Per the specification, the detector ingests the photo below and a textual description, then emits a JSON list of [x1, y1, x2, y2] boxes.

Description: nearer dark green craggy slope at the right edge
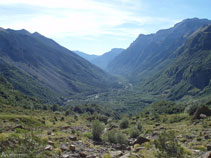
[[141, 25, 211, 99]]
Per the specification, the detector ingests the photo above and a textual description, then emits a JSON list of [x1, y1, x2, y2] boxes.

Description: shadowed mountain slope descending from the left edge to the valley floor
[[0, 28, 113, 102]]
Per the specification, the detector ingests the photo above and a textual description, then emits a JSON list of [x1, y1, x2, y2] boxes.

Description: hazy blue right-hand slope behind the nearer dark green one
[[108, 18, 211, 82]]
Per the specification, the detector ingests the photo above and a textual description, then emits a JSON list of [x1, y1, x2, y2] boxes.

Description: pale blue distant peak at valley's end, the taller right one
[[91, 48, 124, 70]]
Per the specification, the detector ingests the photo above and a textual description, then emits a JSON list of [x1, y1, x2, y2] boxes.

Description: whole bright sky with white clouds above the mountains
[[0, 0, 211, 55]]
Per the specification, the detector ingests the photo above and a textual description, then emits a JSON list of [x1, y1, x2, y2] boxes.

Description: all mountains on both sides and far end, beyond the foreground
[[0, 18, 211, 108]]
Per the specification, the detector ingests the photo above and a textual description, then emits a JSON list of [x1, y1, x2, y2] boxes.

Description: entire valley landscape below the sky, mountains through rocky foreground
[[0, 18, 211, 158]]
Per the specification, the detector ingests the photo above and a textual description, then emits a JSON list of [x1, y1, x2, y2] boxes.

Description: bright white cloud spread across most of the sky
[[0, 0, 178, 53]]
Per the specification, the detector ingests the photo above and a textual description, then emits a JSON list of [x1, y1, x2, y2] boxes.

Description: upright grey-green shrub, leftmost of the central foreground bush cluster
[[92, 120, 104, 141]]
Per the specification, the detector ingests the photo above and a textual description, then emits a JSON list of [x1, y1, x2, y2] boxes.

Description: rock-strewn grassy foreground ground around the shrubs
[[0, 104, 211, 158]]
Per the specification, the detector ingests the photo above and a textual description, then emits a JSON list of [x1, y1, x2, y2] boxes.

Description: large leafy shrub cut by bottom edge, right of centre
[[155, 131, 186, 158]]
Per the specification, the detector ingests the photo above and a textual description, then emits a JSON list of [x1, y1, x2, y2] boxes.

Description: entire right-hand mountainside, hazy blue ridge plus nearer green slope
[[108, 18, 211, 100]]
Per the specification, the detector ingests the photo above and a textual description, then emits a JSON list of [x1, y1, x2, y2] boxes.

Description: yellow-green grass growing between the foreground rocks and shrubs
[[0, 100, 211, 158]]
